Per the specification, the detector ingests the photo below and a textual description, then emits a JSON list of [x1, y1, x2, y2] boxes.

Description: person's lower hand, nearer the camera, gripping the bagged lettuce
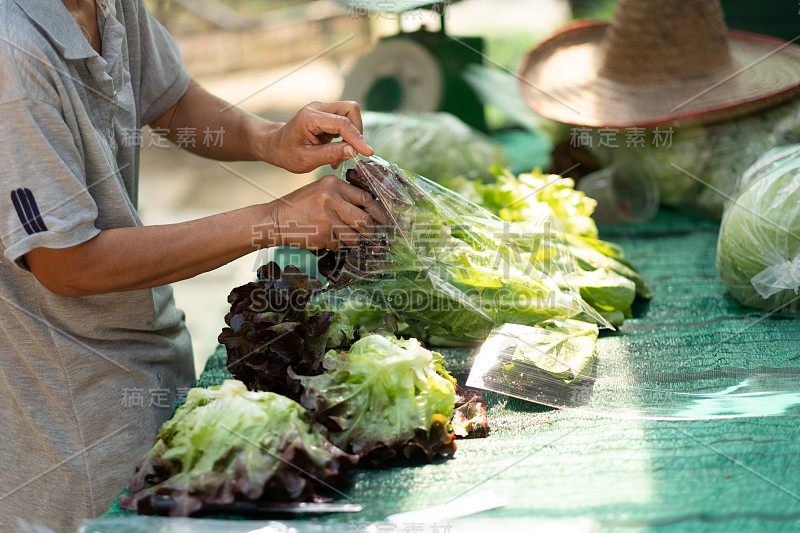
[[261, 175, 388, 251]]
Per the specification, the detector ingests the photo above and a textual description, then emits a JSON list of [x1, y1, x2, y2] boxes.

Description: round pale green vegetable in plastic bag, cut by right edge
[[717, 145, 800, 313]]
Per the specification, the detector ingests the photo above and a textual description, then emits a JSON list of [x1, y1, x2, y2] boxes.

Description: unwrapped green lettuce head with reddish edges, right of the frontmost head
[[292, 334, 455, 460]]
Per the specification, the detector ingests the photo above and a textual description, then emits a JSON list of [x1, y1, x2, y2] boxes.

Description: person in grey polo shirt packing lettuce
[[0, 0, 383, 532]]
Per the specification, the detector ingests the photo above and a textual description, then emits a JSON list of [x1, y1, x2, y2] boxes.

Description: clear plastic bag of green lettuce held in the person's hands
[[319, 156, 608, 343]]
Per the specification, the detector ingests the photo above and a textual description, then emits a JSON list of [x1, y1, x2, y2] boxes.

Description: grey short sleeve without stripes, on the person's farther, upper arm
[[130, 0, 191, 126]]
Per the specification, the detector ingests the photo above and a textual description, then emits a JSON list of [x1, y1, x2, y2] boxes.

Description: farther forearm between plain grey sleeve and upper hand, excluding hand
[[151, 81, 283, 161]]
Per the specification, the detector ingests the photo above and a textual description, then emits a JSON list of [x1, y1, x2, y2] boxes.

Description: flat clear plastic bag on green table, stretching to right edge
[[467, 320, 800, 420]]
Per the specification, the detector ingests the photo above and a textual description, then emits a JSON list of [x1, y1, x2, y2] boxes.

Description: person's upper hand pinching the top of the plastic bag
[[264, 102, 375, 173]]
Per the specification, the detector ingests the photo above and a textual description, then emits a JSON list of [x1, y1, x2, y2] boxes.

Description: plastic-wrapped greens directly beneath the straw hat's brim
[[588, 98, 800, 220]]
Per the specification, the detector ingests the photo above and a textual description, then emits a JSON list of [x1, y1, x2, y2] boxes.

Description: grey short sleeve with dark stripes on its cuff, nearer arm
[[0, 99, 100, 268]]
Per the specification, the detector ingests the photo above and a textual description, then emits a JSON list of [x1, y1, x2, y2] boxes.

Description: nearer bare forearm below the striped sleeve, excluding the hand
[[25, 204, 277, 296]]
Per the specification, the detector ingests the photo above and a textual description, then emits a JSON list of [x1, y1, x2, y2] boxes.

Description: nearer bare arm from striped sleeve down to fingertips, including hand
[[25, 176, 386, 296]]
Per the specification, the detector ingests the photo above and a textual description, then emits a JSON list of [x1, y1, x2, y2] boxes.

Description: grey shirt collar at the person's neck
[[15, 0, 97, 59]]
